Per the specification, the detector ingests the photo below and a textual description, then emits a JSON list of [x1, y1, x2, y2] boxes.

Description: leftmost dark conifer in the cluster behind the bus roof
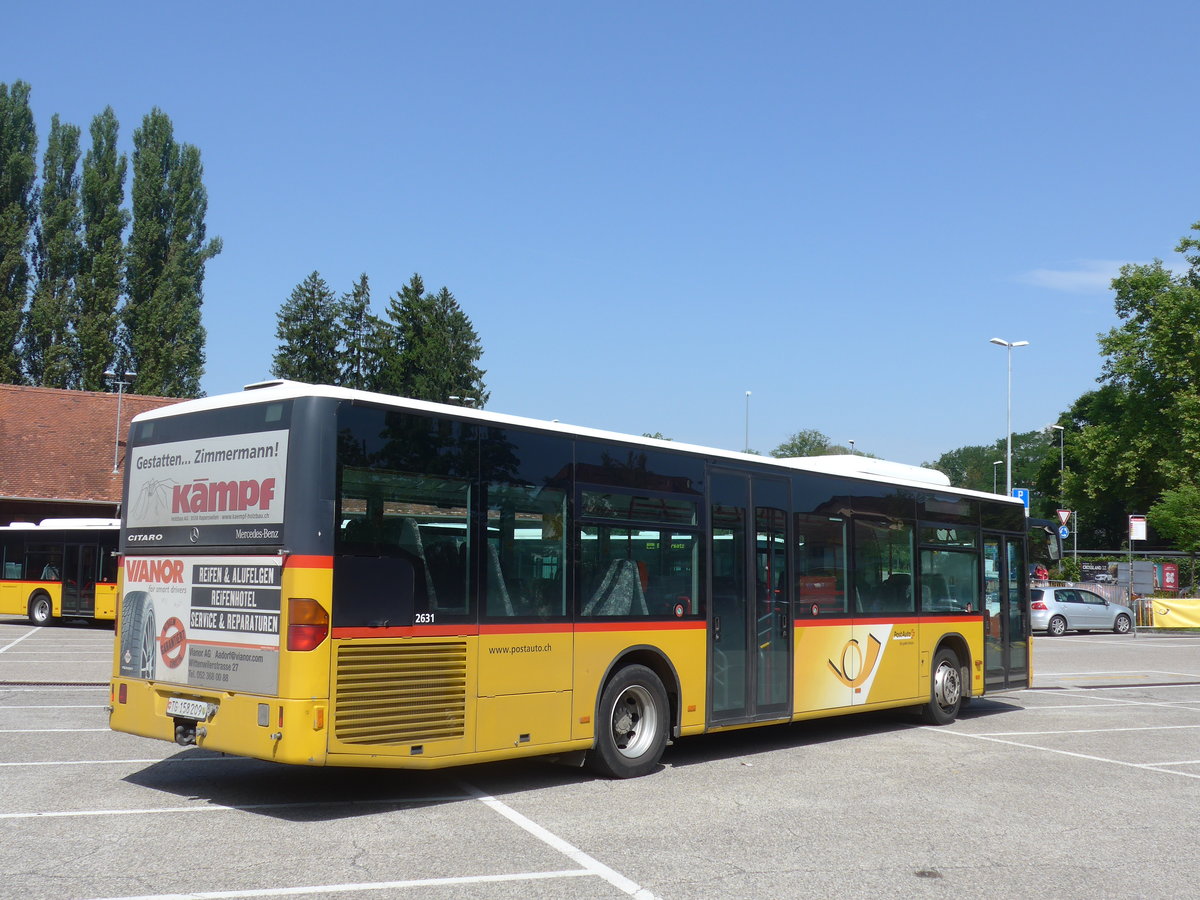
[[271, 271, 342, 384]]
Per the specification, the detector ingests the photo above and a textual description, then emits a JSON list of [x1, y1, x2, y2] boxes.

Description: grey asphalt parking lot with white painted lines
[[0, 619, 1200, 900]]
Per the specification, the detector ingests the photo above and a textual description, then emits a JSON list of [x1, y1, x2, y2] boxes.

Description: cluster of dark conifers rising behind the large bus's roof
[[271, 271, 488, 408]]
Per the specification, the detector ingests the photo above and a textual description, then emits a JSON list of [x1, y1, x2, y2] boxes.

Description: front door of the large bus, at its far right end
[[983, 534, 1030, 690]]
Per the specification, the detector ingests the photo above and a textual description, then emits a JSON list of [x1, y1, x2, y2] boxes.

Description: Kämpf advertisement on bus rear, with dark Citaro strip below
[[126, 431, 288, 547]]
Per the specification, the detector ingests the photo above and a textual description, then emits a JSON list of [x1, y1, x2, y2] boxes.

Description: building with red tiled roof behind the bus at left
[[0, 384, 180, 524]]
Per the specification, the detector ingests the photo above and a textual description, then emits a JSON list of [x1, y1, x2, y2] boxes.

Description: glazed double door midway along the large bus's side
[[708, 470, 792, 725]]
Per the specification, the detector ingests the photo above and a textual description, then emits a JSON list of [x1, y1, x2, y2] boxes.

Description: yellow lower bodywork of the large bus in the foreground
[[110, 618, 984, 769]]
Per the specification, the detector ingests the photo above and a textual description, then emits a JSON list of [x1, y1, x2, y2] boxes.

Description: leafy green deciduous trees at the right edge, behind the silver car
[[926, 222, 1200, 553]]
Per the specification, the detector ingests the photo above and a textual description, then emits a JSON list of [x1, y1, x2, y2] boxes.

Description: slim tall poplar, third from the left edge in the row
[[77, 107, 130, 391]]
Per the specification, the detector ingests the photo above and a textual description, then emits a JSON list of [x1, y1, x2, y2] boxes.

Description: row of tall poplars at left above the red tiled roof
[[0, 80, 221, 397]]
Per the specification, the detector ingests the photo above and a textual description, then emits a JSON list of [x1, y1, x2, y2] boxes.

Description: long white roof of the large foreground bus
[[133, 379, 1021, 504]]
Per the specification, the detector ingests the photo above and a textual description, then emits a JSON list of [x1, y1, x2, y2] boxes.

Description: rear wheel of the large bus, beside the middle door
[[588, 666, 671, 778]]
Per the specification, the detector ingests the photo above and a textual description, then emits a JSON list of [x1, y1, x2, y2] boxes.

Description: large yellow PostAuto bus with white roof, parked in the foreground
[[110, 382, 1030, 778]]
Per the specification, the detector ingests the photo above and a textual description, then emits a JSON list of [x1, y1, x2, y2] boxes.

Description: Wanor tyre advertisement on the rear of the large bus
[[119, 556, 282, 694]]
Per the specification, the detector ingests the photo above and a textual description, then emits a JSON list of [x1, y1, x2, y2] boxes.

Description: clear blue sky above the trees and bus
[[9, 0, 1200, 463]]
